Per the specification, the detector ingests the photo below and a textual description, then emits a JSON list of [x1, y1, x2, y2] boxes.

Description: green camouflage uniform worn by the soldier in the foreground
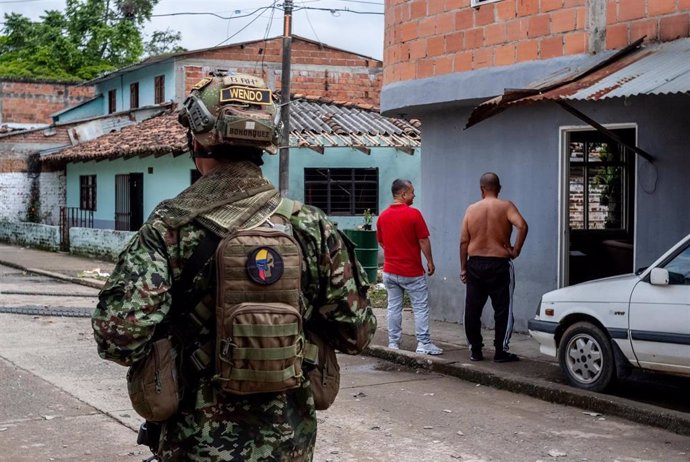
[[92, 161, 376, 462]]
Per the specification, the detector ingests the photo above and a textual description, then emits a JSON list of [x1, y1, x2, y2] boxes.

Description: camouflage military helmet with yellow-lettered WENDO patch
[[179, 73, 282, 154]]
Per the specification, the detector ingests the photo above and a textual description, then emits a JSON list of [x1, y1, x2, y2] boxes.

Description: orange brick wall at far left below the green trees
[[0, 80, 94, 124]]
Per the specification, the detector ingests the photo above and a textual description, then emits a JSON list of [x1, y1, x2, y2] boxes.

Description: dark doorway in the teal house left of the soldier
[[115, 173, 144, 231]]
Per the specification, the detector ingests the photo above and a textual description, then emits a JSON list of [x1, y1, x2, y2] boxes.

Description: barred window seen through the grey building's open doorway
[[568, 129, 634, 231]]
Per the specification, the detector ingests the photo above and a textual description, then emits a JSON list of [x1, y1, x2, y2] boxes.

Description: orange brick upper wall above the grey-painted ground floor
[[383, 0, 690, 85]]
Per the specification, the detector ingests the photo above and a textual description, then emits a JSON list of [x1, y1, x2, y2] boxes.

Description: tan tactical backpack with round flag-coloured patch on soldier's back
[[172, 199, 340, 410]]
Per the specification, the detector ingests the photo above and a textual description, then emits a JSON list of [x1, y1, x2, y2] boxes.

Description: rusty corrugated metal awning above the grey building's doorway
[[465, 38, 690, 162]]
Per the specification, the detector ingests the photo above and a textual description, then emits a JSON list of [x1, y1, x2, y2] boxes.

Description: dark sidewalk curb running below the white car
[[364, 345, 690, 436]]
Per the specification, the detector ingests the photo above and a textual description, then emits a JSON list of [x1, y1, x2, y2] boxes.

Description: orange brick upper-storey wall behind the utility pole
[[180, 39, 383, 106]]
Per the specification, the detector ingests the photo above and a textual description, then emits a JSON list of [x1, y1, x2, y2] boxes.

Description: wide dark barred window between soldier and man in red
[[304, 168, 379, 216]]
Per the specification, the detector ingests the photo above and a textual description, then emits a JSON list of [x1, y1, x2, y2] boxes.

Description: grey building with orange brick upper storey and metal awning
[[381, 0, 690, 331]]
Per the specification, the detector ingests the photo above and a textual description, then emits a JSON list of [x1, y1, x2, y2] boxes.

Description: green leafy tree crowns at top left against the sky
[[0, 0, 180, 81]]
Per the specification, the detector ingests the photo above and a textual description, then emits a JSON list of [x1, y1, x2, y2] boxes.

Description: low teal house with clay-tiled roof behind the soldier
[[41, 95, 421, 249]]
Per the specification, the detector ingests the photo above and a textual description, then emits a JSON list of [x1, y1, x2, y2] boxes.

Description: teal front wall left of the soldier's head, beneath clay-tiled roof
[[66, 155, 195, 228]]
